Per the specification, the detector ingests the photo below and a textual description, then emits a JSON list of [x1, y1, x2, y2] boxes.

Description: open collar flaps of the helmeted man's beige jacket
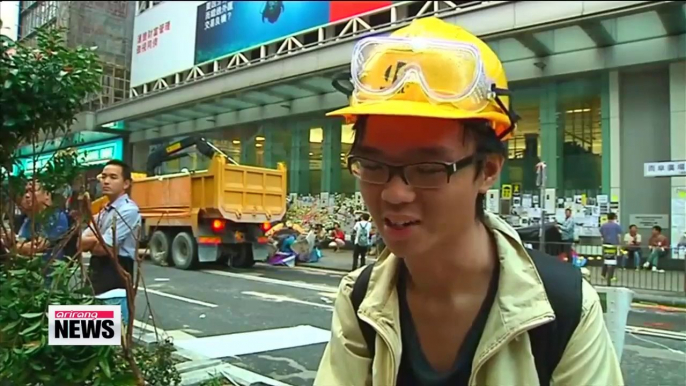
[[360, 214, 554, 351]]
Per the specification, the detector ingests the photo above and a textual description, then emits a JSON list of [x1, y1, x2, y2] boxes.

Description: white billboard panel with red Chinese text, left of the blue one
[[131, 1, 205, 87]]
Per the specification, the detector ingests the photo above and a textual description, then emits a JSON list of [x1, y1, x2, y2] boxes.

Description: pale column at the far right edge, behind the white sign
[[669, 61, 686, 256]]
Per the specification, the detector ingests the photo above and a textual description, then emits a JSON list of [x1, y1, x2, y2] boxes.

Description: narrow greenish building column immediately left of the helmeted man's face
[[322, 119, 341, 194]]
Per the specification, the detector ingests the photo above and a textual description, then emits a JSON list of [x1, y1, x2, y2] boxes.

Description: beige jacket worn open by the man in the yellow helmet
[[314, 215, 624, 386]]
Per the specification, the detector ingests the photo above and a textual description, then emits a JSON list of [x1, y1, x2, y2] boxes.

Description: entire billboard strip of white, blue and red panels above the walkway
[[131, 1, 393, 87]]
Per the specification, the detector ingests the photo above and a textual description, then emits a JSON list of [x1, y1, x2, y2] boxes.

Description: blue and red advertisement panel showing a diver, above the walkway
[[195, 1, 392, 64]]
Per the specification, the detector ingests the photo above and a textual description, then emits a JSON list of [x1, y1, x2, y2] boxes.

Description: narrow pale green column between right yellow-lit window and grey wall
[[600, 71, 621, 200]]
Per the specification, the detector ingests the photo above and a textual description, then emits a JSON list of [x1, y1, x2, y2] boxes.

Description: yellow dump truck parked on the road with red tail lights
[[92, 137, 287, 269]]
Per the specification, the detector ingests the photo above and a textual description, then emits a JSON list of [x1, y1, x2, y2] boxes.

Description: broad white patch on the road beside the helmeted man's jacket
[[175, 325, 331, 359]]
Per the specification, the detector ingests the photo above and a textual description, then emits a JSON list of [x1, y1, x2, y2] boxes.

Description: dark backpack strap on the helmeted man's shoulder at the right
[[527, 249, 583, 386]]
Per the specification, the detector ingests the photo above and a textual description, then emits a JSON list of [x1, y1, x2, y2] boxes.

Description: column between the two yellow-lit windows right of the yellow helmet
[[540, 83, 564, 191]]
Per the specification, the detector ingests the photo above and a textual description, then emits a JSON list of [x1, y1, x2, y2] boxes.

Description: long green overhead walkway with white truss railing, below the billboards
[[73, 1, 686, 142]]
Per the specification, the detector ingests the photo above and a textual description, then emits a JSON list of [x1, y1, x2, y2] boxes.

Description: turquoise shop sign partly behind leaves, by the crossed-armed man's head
[[19, 138, 124, 175]]
